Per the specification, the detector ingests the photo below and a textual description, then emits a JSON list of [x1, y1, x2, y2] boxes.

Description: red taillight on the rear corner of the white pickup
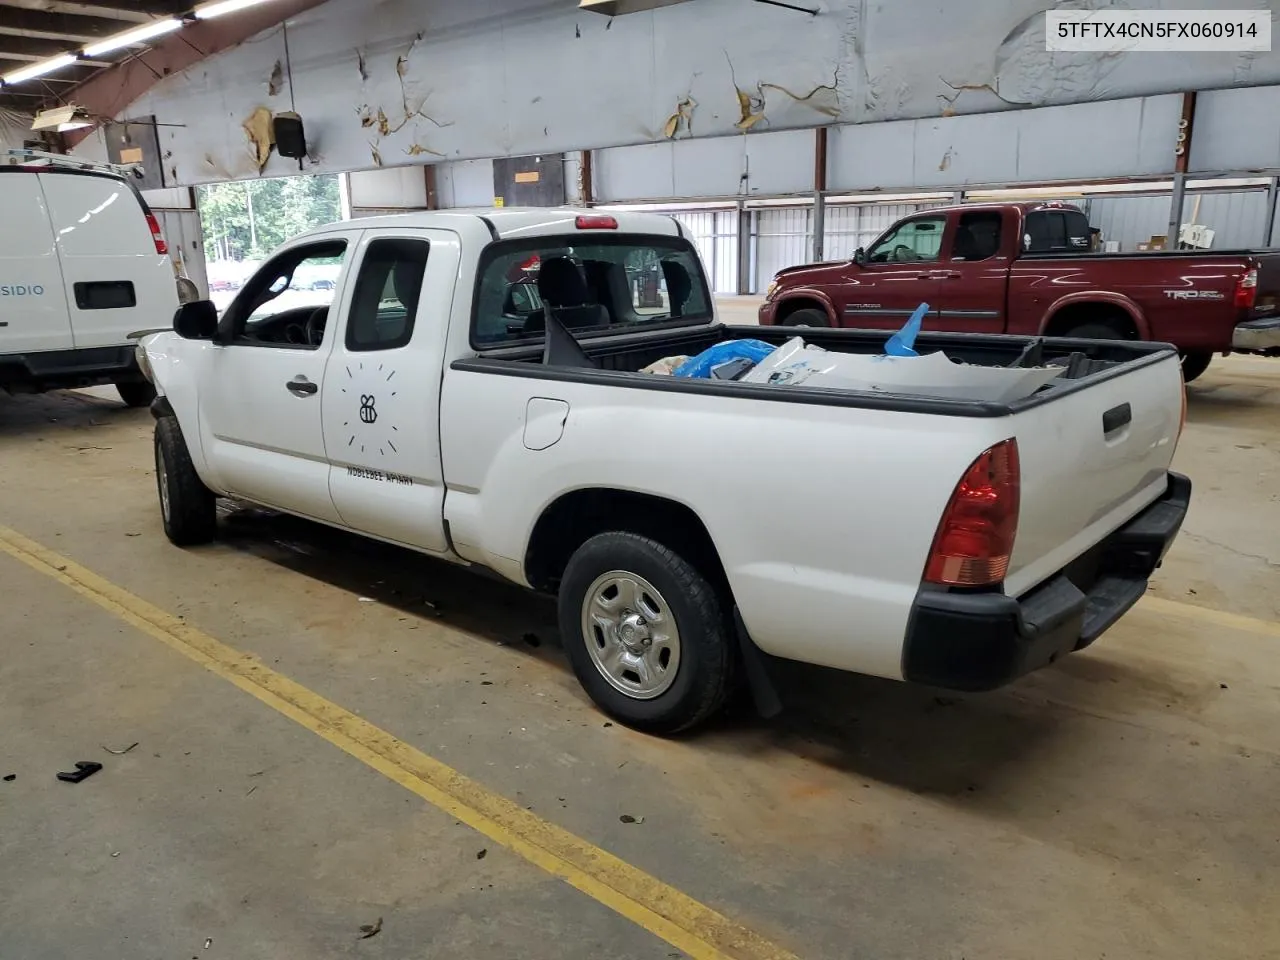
[[924, 438, 1020, 586]]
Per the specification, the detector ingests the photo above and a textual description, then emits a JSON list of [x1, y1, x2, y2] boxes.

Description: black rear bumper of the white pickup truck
[[902, 474, 1192, 690]]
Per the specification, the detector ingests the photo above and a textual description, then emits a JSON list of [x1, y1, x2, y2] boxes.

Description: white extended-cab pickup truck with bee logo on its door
[[138, 210, 1190, 732]]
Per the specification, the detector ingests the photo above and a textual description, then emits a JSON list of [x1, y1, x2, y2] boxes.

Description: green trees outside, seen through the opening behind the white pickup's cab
[[196, 174, 342, 261]]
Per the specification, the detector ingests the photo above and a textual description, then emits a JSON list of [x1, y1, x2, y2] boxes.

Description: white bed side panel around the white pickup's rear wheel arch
[[442, 370, 1007, 678]]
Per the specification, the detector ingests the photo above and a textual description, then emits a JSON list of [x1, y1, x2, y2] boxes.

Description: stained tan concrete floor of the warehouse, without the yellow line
[[0, 358, 1280, 960]]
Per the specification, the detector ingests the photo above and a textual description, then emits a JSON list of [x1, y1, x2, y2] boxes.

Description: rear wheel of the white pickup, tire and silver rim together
[[559, 532, 736, 733]]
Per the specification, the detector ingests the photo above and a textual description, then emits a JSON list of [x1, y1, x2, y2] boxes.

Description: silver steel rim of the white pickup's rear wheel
[[582, 570, 680, 700]]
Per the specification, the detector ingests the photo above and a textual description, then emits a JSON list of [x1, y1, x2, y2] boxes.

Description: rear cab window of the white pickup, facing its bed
[[472, 236, 712, 346]]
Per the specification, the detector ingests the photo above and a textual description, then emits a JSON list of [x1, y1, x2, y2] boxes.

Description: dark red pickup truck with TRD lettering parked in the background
[[760, 204, 1280, 380]]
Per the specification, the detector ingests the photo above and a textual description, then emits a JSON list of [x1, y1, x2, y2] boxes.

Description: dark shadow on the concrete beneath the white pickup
[[209, 504, 1162, 803]]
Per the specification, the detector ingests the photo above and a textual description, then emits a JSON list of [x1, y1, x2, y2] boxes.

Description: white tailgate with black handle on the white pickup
[[1005, 353, 1183, 596]]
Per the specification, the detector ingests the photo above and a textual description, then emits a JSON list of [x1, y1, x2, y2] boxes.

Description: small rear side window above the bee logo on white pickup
[[347, 237, 430, 351]]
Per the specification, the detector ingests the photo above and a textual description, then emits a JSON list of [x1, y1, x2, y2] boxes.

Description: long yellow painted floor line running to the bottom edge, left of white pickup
[[0, 526, 796, 960]]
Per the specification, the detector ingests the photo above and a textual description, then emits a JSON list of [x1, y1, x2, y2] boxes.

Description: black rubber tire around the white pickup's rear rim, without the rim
[[558, 532, 737, 733]]
